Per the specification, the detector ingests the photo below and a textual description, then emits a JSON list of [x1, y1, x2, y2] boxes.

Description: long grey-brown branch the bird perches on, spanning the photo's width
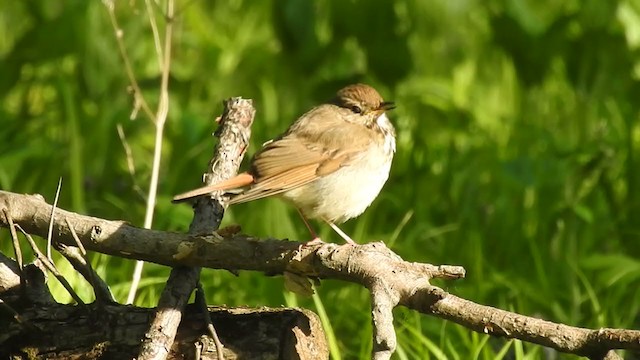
[[0, 191, 640, 358]]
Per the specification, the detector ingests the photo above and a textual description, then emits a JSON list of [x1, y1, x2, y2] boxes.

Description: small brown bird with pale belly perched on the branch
[[173, 84, 396, 243]]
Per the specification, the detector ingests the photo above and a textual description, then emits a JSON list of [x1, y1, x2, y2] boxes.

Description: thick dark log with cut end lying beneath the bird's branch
[[0, 250, 329, 360]]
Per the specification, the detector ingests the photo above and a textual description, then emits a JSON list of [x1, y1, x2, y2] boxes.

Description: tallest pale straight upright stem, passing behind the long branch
[[127, 0, 174, 304]]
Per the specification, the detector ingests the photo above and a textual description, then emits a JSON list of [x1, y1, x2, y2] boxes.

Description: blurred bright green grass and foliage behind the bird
[[0, 0, 640, 359]]
